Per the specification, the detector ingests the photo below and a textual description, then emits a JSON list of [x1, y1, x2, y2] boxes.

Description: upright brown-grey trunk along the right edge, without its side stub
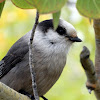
[[93, 19, 100, 100]]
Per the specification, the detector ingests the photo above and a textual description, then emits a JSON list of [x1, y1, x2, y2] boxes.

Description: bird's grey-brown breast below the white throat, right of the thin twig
[[33, 48, 66, 96]]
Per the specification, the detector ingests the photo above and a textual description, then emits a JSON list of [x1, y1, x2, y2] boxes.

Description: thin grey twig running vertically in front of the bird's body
[[29, 11, 39, 100]]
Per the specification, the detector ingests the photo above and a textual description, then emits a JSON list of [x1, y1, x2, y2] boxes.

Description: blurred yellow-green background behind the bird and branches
[[0, 0, 96, 100]]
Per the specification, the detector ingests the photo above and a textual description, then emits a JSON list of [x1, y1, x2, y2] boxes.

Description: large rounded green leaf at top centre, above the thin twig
[[32, 0, 67, 14]]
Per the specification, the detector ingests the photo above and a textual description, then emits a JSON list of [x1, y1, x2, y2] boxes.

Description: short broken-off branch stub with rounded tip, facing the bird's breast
[[80, 46, 97, 93]]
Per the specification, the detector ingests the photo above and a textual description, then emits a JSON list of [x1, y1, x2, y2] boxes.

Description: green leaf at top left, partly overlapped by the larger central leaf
[[12, 0, 35, 9]]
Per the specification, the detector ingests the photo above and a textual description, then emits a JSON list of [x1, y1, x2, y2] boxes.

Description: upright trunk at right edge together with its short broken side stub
[[80, 19, 100, 100]]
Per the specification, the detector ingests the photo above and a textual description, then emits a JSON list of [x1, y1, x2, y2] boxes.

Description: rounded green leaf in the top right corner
[[76, 0, 100, 19]]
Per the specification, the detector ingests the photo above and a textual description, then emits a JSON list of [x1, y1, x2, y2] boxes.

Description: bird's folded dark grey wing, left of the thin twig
[[0, 37, 29, 78]]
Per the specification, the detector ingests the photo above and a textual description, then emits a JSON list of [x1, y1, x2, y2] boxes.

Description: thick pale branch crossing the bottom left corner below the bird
[[0, 82, 31, 100]]
